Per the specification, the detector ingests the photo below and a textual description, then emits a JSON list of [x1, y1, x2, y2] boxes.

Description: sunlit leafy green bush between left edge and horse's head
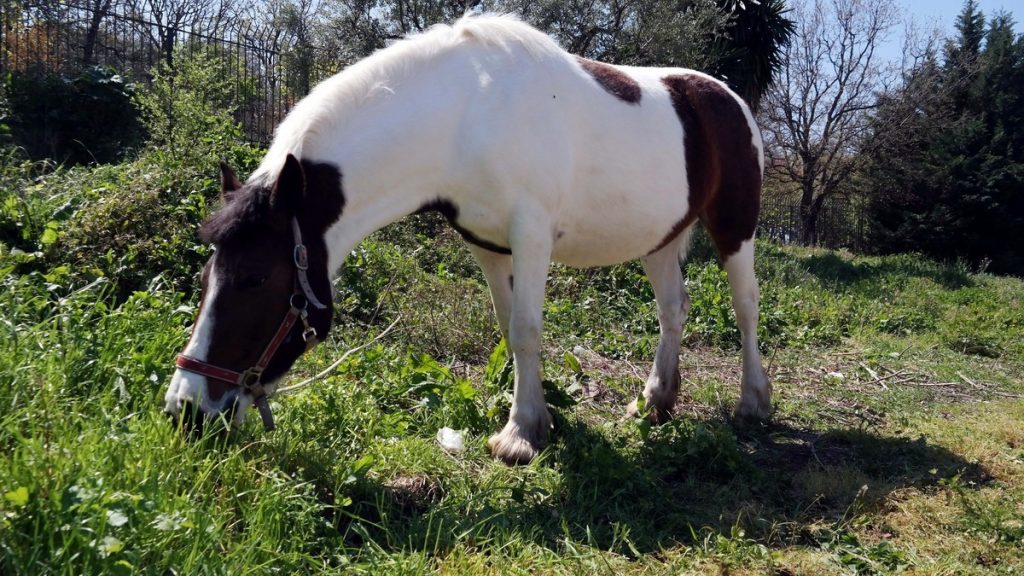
[[0, 45, 263, 298]]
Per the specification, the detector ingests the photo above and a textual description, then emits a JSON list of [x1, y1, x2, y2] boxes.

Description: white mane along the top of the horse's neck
[[249, 14, 567, 186]]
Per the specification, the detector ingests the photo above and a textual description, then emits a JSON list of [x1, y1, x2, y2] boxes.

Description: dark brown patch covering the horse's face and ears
[[200, 160, 345, 402]]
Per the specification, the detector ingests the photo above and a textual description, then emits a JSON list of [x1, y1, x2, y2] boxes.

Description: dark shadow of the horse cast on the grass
[[325, 412, 988, 557]]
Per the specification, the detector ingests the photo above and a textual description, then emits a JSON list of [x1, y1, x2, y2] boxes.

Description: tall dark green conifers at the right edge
[[865, 1, 1024, 274]]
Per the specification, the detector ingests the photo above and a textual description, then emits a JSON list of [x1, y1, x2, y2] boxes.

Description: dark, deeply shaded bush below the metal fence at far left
[[0, 66, 143, 164]]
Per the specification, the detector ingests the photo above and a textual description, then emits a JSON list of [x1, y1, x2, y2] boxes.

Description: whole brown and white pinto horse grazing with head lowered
[[165, 14, 771, 464]]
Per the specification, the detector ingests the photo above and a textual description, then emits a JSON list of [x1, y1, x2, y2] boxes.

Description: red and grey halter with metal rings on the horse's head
[[174, 217, 327, 430]]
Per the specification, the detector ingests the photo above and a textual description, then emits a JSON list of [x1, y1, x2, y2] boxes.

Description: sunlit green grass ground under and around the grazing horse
[[0, 199, 1024, 575]]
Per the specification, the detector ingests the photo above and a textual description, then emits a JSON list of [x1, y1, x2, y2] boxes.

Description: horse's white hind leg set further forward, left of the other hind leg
[[628, 227, 692, 422]]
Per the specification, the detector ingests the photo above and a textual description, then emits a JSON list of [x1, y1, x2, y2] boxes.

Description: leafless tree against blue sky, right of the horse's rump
[[762, 0, 899, 243]]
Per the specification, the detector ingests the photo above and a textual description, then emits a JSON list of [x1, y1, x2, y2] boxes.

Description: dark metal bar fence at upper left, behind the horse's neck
[[0, 0, 336, 145]]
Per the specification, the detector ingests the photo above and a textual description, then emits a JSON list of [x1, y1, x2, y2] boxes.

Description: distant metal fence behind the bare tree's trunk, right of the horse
[[758, 197, 866, 251]]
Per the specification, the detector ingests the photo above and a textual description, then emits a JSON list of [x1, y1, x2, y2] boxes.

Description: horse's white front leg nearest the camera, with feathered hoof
[[487, 216, 551, 464]]
